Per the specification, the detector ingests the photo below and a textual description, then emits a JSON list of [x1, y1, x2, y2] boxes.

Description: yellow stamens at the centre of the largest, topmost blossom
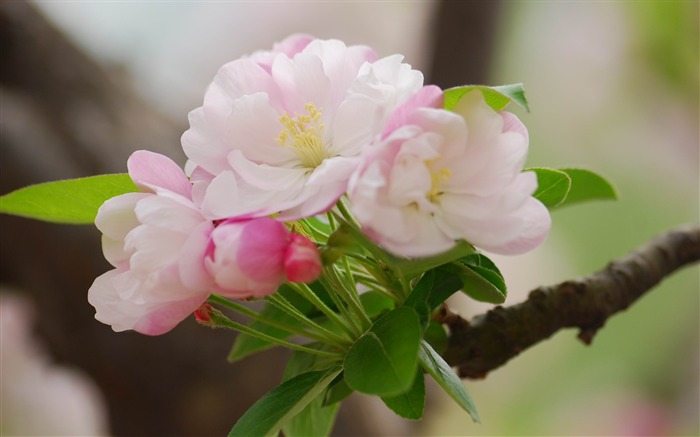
[[276, 103, 330, 169]]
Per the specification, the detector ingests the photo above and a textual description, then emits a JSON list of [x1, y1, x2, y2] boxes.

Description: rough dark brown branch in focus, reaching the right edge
[[440, 225, 700, 378]]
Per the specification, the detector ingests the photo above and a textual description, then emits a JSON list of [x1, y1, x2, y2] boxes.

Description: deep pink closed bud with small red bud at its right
[[205, 218, 321, 299]]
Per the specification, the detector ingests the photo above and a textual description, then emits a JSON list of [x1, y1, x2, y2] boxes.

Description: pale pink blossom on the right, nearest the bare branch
[[349, 87, 551, 257]]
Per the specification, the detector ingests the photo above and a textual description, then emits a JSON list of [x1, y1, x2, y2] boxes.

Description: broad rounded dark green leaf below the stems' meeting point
[[344, 306, 421, 396]]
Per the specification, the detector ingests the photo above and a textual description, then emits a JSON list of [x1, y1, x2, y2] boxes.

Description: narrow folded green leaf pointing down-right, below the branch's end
[[418, 341, 479, 422]]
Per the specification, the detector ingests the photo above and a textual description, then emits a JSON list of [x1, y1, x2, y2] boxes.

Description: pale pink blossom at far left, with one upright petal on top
[[88, 151, 213, 335]]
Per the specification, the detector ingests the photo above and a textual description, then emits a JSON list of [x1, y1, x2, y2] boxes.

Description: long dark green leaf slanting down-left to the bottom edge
[[228, 367, 342, 437]]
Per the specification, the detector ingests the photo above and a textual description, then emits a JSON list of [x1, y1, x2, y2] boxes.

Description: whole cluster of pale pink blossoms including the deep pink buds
[[89, 35, 550, 335]]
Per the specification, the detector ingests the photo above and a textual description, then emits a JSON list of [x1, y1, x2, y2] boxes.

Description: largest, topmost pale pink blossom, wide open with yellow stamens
[[182, 35, 423, 220]]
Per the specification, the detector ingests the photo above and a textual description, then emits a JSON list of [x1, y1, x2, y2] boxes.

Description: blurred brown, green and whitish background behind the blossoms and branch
[[0, 1, 700, 436]]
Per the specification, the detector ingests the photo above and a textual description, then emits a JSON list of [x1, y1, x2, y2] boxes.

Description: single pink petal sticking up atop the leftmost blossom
[[127, 150, 192, 199]]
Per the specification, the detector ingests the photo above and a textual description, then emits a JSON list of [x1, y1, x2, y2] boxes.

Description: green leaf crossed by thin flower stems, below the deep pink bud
[[228, 285, 313, 363]]
